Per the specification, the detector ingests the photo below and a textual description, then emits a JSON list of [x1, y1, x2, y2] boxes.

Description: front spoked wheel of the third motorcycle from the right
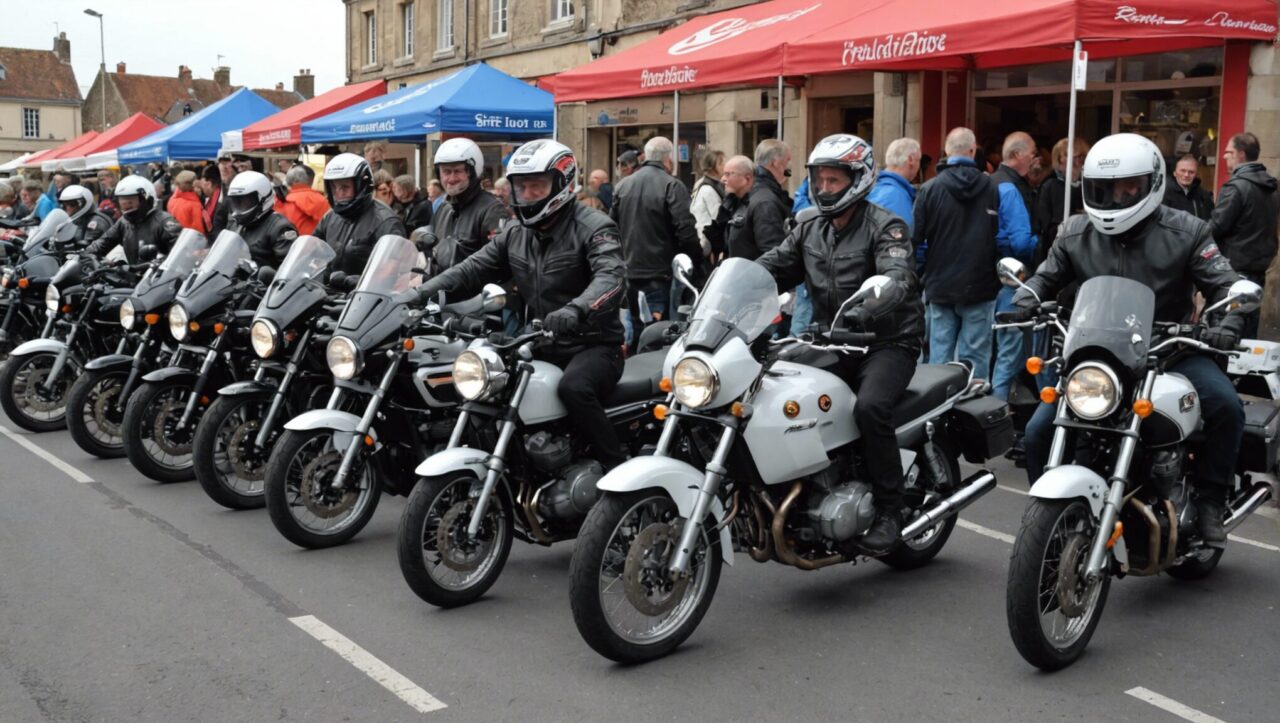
[[397, 475, 512, 608]]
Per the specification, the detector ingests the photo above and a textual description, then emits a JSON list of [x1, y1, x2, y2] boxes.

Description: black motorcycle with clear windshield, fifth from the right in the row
[[192, 235, 335, 509]]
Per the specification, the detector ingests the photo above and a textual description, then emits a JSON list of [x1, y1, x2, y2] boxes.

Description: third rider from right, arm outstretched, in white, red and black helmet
[[419, 141, 626, 470]]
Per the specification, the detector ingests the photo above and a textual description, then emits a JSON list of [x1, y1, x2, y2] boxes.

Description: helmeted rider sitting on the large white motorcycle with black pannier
[[759, 133, 924, 553]]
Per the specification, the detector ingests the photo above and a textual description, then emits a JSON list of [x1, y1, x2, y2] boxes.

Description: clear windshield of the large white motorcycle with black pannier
[[686, 258, 778, 347]]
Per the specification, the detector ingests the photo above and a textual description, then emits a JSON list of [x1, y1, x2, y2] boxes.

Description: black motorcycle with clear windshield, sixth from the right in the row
[[120, 230, 271, 482]]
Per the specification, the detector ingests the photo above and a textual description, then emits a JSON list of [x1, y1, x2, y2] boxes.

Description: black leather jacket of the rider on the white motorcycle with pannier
[[759, 201, 924, 351]]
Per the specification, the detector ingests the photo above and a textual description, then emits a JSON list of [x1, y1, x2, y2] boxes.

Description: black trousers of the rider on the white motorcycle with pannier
[[835, 347, 916, 509]]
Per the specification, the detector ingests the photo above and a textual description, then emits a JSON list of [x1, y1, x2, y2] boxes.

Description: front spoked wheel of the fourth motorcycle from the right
[[265, 429, 381, 549]]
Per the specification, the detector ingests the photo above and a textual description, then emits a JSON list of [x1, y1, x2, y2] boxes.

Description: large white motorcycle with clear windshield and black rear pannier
[[570, 257, 1012, 663]]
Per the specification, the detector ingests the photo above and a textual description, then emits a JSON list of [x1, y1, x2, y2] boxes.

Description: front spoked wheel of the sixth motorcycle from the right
[[123, 379, 204, 482]]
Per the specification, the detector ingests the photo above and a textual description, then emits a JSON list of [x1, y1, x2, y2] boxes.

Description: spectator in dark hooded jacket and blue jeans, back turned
[[913, 128, 1000, 379]]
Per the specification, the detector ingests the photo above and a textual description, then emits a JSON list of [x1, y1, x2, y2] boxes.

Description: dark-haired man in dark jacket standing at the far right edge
[[1210, 133, 1280, 339]]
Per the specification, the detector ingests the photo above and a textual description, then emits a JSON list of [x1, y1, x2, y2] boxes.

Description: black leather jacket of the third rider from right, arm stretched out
[[424, 202, 626, 351]]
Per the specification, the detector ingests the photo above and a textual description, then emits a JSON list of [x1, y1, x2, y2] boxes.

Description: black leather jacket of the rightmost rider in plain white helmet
[[1014, 206, 1240, 322]]
